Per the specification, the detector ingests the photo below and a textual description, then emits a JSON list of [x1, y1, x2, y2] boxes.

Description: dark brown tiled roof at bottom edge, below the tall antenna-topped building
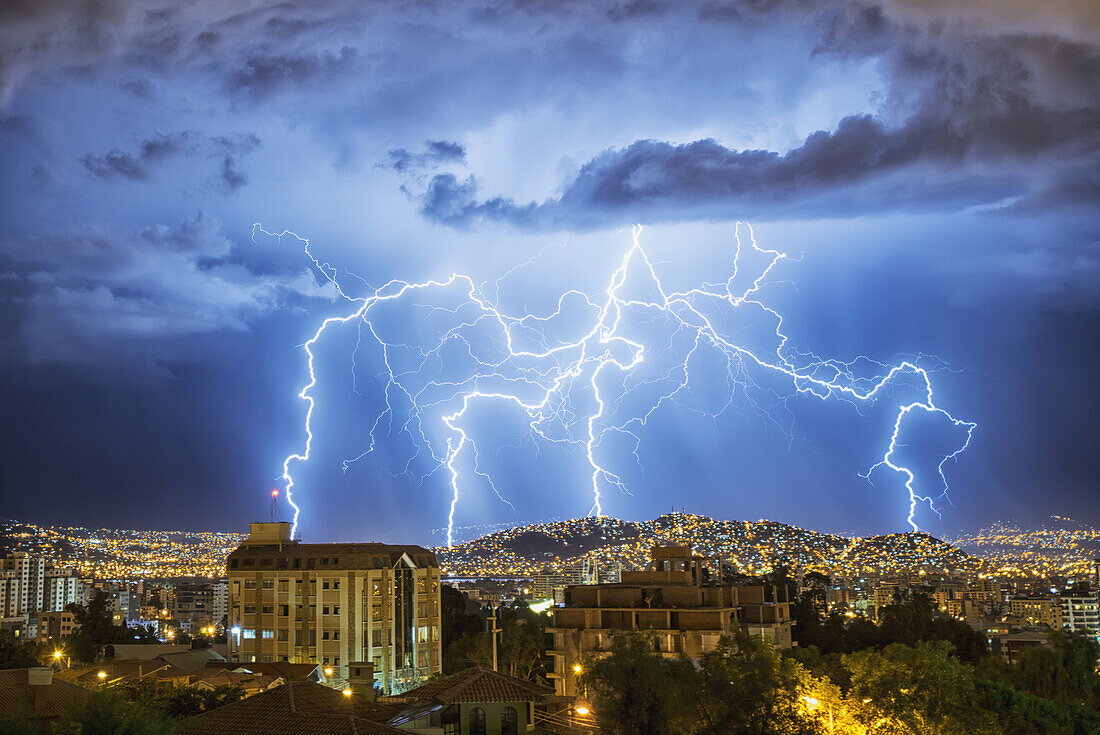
[[177, 681, 407, 735]]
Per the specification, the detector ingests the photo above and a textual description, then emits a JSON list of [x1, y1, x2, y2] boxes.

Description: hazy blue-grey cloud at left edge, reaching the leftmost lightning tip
[[0, 213, 329, 374]]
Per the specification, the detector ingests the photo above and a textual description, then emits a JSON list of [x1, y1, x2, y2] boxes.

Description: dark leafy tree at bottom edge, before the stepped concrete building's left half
[[581, 633, 699, 735]]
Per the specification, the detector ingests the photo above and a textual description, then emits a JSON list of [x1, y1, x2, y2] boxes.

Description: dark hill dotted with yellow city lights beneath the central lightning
[[435, 513, 987, 575]]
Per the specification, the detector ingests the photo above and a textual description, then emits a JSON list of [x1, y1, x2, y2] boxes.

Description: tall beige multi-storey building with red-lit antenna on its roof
[[229, 523, 442, 693]]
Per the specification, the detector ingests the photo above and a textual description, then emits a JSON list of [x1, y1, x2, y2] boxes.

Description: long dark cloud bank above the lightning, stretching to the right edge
[[420, 20, 1100, 229]]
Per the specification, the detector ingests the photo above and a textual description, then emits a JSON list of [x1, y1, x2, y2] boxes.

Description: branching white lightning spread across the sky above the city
[[259, 222, 977, 547]]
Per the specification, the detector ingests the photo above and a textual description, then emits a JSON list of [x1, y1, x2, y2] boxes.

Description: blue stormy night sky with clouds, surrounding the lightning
[[0, 0, 1100, 542]]
